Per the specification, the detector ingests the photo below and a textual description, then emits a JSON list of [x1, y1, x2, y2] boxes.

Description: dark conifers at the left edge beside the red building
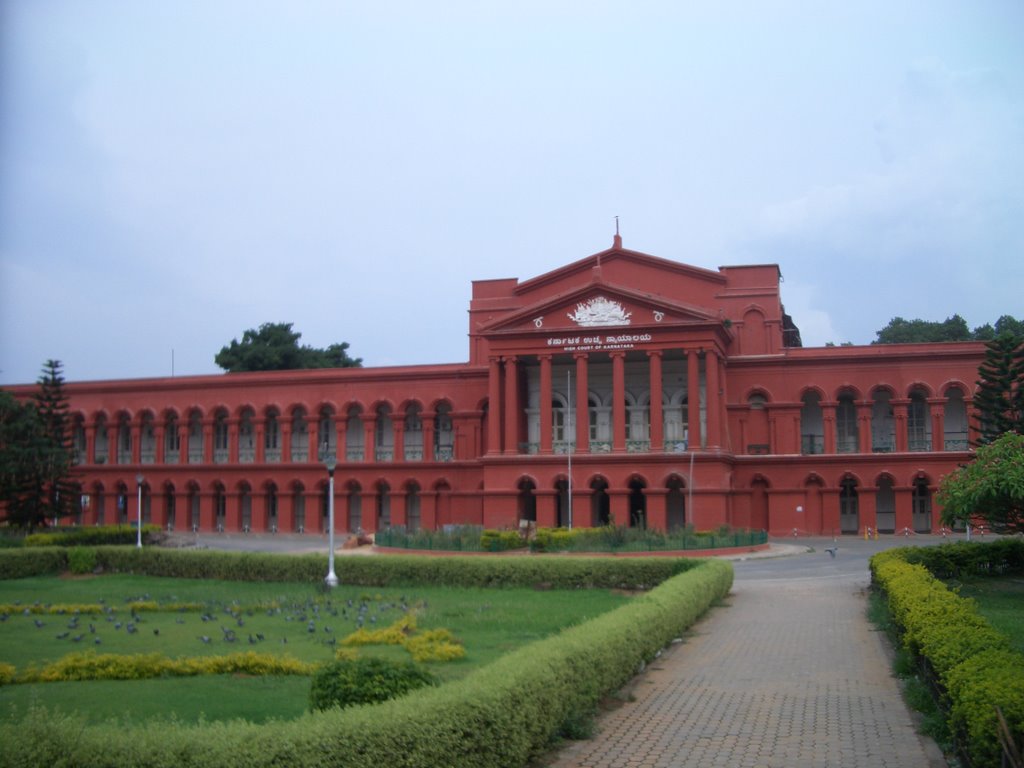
[[0, 360, 79, 530]]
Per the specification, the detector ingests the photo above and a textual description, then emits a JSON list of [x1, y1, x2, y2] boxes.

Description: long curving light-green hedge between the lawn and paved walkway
[[0, 557, 732, 768]]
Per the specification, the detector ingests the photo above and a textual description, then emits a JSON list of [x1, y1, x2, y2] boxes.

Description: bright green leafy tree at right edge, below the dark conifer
[[936, 432, 1024, 534]]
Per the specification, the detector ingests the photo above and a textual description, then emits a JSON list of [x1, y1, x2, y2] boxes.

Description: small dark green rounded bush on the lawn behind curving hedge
[[309, 658, 435, 710]]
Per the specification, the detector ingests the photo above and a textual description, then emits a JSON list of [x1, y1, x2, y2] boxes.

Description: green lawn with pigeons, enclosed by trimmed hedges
[[0, 574, 629, 722]]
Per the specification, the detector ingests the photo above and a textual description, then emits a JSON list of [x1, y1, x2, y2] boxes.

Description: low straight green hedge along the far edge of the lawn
[[0, 547, 695, 589]]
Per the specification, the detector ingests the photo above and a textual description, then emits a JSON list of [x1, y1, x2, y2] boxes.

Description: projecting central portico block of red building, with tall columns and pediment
[[470, 236, 782, 527]]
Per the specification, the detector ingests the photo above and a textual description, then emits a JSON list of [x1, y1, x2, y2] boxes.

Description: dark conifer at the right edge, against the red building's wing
[[974, 333, 1024, 444]]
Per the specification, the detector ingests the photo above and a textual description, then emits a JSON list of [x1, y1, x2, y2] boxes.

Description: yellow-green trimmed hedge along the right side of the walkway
[[870, 542, 1024, 768]]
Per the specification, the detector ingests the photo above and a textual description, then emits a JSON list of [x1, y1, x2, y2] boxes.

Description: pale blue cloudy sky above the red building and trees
[[0, 0, 1024, 384]]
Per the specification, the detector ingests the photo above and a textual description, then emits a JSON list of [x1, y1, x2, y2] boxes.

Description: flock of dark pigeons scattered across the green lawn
[[0, 595, 426, 646]]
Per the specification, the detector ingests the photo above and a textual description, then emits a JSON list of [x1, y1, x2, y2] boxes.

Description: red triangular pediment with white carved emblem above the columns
[[479, 283, 718, 333]]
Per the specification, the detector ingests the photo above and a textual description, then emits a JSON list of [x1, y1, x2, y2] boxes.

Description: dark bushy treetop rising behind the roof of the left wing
[[213, 323, 362, 373]]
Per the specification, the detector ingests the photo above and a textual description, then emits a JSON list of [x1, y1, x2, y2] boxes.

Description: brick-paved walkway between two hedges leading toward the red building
[[548, 540, 945, 768]]
